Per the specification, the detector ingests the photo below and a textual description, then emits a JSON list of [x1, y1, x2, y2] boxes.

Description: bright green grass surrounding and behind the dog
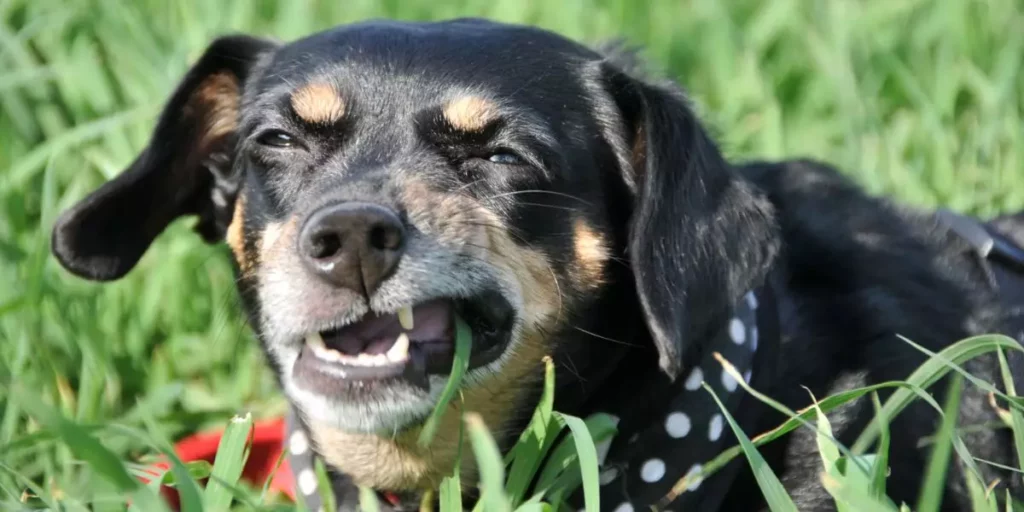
[[0, 0, 1024, 510]]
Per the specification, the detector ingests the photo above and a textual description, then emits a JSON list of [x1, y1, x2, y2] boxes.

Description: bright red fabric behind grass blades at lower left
[[139, 418, 295, 510]]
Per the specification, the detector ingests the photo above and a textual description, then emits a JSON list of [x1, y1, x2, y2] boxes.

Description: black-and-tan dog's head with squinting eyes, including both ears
[[53, 20, 776, 487]]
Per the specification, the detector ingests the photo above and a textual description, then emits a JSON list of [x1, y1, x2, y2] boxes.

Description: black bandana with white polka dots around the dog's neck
[[288, 287, 779, 512]]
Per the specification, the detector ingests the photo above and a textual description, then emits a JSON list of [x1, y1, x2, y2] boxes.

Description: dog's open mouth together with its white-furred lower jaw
[[282, 292, 515, 434]]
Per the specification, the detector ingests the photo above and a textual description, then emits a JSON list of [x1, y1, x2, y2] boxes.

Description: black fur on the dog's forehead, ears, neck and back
[[53, 20, 1024, 510]]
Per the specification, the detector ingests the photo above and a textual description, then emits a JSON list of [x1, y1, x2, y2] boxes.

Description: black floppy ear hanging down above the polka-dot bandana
[[603, 60, 779, 378]]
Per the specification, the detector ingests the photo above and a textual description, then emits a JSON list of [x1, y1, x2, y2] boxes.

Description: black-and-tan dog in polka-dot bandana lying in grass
[[52, 19, 1024, 511]]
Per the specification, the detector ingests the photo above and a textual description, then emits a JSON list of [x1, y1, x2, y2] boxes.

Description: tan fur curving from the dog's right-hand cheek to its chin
[[310, 181, 562, 490]]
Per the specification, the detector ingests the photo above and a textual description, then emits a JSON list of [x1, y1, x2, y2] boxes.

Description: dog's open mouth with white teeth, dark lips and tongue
[[292, 293, 514, 392]]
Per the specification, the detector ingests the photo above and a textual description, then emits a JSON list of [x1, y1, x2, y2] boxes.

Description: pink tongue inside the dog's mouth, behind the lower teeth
[[324, 300, 452, 355]]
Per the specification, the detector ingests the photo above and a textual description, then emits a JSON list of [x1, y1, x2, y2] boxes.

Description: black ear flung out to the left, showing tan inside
[[52, 36, 274, 281]]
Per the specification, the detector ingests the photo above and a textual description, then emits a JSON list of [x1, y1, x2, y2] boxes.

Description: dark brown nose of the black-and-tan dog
[[299, 203, 406, 296]]
